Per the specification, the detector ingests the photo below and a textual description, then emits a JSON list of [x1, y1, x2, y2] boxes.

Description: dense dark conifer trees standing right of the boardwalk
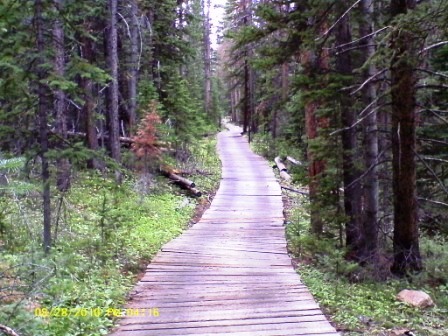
[[220, 0, 448, 276]]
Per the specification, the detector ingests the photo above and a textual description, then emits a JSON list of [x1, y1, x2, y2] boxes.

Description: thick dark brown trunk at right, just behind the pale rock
[[390, 0, 422, 276]]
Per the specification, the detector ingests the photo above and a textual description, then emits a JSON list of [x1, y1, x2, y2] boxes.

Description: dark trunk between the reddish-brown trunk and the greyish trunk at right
[[336, 1, 363, 260]]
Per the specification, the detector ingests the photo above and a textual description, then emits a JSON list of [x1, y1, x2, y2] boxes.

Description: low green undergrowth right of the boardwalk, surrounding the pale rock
[[252, 137, 448, 336]]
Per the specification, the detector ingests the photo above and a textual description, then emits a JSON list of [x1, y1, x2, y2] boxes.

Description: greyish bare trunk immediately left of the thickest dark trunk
[[360, 0, 379, 264]]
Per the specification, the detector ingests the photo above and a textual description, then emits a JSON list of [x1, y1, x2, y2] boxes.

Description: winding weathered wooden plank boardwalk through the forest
[[111, 128, 339, 336]]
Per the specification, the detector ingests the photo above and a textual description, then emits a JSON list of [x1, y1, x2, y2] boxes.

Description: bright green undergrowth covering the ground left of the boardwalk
[[0, 138, 220, 336]]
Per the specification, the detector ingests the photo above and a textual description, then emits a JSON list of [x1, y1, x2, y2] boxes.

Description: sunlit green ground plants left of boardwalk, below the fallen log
[[0, 174, 195, 336]]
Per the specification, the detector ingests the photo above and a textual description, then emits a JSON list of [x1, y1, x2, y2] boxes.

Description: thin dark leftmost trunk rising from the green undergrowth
[[34, 0, 51, 253]]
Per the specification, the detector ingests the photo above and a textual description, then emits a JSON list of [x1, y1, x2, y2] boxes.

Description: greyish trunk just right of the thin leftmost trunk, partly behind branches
[[53, 0, 70, 191]]
